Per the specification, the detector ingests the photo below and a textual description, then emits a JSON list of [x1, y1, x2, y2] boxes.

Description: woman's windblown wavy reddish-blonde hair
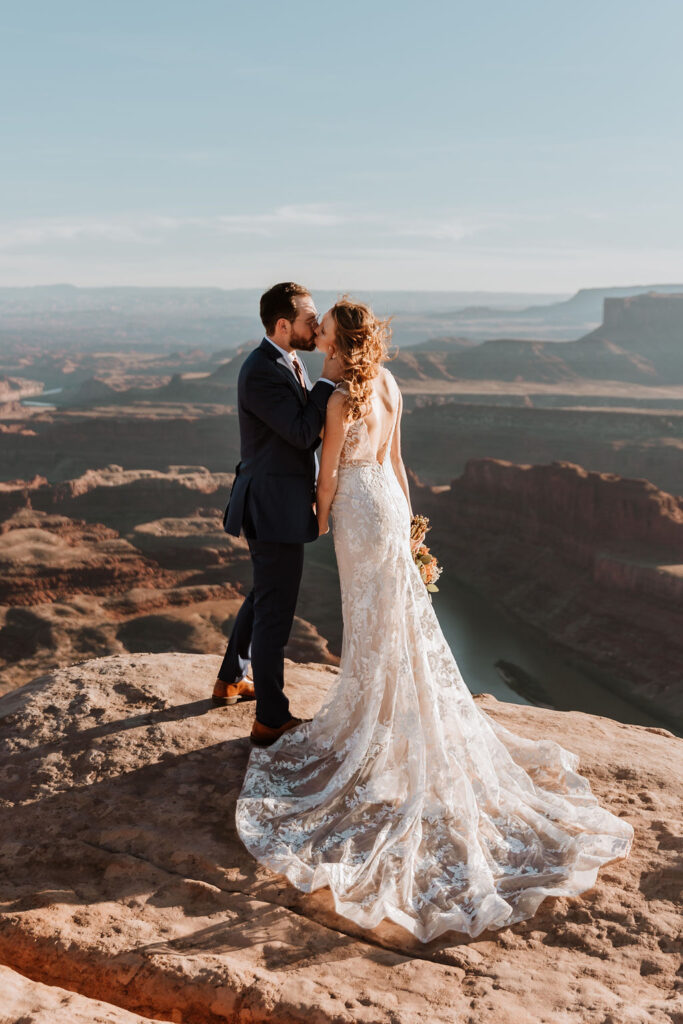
[[331, 295, 391, 420]]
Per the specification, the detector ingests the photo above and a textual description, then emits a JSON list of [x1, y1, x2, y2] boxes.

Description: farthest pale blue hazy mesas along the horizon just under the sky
[[0, 284, 683, 358]]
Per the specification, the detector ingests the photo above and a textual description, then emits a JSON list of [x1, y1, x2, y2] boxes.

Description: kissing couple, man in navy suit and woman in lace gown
[[213, 283, 633, 942]]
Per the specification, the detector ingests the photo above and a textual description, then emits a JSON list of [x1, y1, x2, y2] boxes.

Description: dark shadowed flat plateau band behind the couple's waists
[[0, 385, 683, 494]]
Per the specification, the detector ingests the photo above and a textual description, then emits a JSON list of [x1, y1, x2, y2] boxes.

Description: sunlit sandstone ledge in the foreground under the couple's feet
[[0, 654, 683, 1024]]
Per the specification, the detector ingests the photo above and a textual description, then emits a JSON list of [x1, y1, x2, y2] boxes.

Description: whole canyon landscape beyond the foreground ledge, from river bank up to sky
[[0, 286, 683, 728]]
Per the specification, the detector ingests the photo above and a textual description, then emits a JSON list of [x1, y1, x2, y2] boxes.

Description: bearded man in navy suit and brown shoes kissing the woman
[[213, 282, 341, 746]]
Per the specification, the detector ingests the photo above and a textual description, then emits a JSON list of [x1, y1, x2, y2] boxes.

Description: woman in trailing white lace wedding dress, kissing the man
[[237, 299, 633, 942]]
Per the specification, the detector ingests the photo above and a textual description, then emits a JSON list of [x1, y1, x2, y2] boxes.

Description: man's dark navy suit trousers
[[218, 538, 303, 729]]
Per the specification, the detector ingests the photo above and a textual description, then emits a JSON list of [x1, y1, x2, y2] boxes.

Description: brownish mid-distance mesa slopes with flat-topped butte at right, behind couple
[[41, 292, 683, 407]]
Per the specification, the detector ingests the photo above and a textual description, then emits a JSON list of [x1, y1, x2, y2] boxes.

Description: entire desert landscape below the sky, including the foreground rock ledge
[[0, 285, 683, 1024]]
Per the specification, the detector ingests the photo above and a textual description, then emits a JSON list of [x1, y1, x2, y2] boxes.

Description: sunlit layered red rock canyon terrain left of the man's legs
[[0, 466, 337, 692]]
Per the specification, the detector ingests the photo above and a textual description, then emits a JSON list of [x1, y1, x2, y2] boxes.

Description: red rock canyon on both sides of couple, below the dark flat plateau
[[0, 459, 683, 729]]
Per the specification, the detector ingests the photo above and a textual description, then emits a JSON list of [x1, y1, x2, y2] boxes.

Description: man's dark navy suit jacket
[[223, 338, 334, 544]]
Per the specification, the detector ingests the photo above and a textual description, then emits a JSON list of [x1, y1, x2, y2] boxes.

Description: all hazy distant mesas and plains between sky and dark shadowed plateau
[[5, 285, 683, 409]]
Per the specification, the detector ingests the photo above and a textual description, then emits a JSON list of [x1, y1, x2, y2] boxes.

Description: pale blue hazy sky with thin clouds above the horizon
[[0, 0, 683, 292]]
